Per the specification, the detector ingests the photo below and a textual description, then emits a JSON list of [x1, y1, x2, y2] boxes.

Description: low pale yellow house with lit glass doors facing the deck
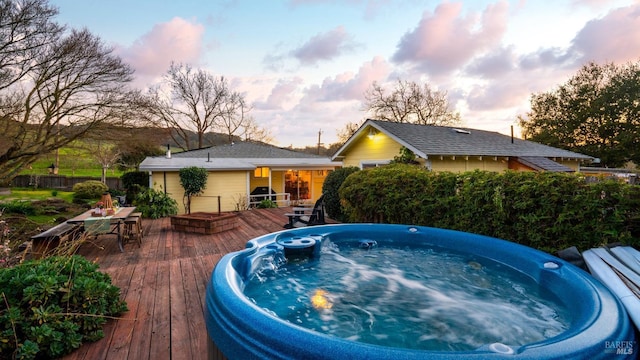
[[139, 142, 341, 213]]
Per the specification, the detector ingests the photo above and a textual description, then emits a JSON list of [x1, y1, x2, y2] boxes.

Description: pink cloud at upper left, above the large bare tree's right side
[[117, 17, 204, 78]]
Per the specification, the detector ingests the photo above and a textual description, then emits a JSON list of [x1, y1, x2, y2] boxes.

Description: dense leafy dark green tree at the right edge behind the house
[[518, 62, 640, 167]]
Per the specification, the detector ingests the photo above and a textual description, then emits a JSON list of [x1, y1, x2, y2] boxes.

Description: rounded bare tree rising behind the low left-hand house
[[150, 63, 270, 150]]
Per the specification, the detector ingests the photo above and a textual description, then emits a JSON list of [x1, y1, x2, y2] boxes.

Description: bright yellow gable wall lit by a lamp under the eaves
[[343, 133, 401, 167]]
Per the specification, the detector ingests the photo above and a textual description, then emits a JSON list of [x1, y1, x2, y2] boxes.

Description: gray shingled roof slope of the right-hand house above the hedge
[[365, 120, 593, 160]]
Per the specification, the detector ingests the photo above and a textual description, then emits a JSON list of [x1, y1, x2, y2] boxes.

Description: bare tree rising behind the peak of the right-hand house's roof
[[364, 80, 460, 125]]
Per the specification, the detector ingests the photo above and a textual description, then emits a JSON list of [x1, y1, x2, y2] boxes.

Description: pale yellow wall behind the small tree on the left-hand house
[[152, 171, 247, 214]]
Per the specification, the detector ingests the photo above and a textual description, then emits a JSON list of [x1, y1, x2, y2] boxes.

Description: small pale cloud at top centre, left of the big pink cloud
[[291, 26, 357, 65]]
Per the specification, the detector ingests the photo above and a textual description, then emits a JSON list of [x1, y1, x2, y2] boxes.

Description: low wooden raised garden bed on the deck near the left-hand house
[[171, 212, 238, 235]]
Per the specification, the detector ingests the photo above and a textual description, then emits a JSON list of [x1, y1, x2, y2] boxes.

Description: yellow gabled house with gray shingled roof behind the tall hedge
[[332, 119, 594, 172]]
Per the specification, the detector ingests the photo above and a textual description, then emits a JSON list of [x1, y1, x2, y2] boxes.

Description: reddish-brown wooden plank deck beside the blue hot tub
[[64, 208, 291, 360]]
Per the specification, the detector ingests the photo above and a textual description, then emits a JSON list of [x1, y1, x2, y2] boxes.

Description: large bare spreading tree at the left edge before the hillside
[[0, 18, 132, 183]]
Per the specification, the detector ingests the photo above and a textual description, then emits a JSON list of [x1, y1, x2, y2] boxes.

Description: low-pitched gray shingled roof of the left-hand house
[[172, 142, 327, 159]]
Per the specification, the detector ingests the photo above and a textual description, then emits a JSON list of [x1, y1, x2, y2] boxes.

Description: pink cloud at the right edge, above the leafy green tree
[[571, 4, 640, 63]]
